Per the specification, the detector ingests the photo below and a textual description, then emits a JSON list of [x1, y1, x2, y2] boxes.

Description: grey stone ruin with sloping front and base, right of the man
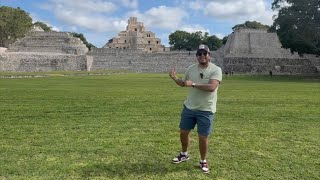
[[221, 28, 319, 74]]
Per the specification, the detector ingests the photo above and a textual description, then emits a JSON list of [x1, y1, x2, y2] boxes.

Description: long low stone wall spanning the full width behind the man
[[0, 48, 320, 74]]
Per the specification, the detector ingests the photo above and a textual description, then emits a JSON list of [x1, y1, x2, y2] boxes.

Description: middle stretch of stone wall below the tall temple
[[87, 48, 222, 73]]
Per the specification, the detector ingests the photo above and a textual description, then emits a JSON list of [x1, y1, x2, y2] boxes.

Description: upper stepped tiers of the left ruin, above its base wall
[[7, 31, 88, 55]]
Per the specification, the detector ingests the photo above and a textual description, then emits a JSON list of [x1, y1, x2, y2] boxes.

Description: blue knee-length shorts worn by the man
[[179, 106, 214, 136]]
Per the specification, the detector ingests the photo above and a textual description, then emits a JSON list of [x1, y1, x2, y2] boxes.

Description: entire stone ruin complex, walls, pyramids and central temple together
[[0, 17, 320, 75]]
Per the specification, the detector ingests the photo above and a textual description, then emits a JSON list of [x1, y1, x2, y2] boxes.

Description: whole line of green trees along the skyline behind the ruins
[[0, 0, 320, 55]]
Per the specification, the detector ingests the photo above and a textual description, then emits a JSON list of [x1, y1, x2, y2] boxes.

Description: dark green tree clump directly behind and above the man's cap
[[169, 30, 222, 50]]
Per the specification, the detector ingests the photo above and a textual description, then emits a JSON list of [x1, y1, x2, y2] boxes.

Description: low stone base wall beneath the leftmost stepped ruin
[[0, 52, 87, 72]]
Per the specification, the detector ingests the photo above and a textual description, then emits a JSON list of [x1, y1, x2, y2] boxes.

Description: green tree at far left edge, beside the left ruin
[[0, 6, 32, 47]]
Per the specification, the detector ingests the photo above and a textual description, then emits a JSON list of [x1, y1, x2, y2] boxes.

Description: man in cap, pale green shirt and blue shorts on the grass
[[169, 45, 222, 173]]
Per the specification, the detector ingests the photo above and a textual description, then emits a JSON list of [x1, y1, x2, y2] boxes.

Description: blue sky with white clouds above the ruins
[[0, 0, 277, 47]]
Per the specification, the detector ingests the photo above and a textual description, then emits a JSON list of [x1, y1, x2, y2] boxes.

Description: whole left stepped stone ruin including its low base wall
[[0, 31, 88, 72]]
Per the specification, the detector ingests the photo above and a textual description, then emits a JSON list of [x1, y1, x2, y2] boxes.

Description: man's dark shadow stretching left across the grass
[[78, 161, 190, 178]]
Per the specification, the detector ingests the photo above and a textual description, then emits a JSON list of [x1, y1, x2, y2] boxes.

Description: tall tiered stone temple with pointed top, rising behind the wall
[[103, 17, 165, 52]]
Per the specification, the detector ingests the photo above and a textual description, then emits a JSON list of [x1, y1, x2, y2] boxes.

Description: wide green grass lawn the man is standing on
[[0, 73, 320, 180]]
